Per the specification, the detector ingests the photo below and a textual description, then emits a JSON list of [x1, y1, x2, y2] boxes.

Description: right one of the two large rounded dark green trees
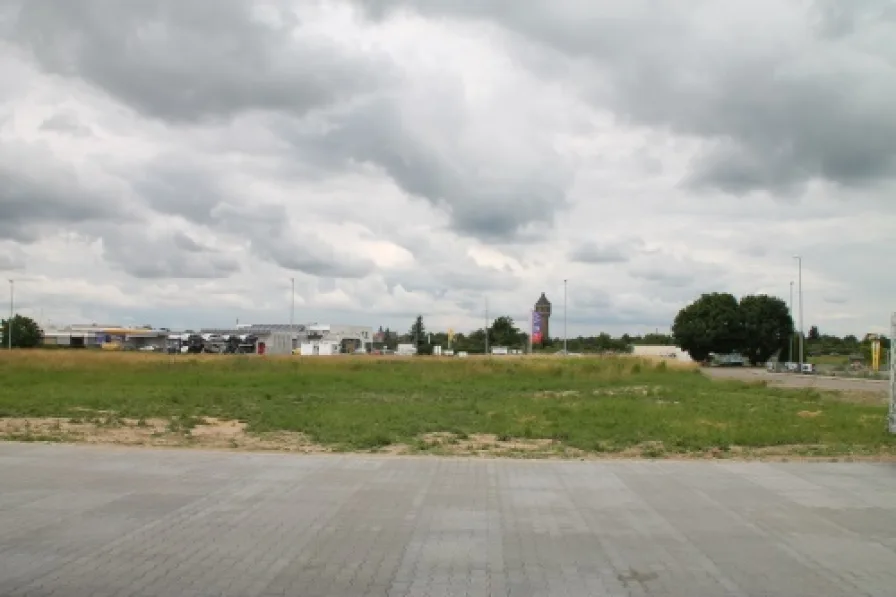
[[739, 294, 793, 365]]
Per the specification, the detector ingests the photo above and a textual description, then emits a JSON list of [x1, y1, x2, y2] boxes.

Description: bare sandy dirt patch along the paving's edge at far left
[[0, 415, 330, 453]]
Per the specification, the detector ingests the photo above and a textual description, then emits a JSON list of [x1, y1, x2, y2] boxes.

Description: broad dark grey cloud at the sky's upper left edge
[[5, 0, 389, 121]]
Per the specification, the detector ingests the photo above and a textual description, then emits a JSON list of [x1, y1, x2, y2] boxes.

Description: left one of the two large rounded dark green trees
[[672, 292, 744, 361]]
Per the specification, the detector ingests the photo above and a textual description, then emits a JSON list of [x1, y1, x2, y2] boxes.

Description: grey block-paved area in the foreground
[[0, 443, 896, 597]]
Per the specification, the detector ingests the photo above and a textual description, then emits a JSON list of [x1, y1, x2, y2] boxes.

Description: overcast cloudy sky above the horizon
[[0, 0, 896, 335]]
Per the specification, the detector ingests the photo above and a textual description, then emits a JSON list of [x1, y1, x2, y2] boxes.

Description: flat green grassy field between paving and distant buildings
[[0, 351, 896, 457]]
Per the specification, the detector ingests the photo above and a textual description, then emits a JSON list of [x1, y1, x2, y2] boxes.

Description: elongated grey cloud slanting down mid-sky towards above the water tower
[[284, 96, 571, 243]]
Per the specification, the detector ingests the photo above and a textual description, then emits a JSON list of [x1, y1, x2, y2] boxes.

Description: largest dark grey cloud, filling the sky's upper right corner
[[359, 0, 896, 194]]
